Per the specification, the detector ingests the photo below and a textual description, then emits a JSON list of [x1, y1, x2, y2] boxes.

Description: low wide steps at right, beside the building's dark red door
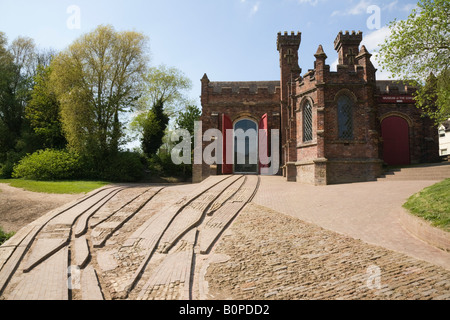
[[378, 162, 450, 181]]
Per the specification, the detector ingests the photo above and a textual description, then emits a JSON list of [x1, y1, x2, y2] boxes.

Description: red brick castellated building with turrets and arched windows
[[194, 32, 439, 185]]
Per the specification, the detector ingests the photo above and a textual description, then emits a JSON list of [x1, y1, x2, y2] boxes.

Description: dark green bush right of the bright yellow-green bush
[[100, 151, 145, 182]]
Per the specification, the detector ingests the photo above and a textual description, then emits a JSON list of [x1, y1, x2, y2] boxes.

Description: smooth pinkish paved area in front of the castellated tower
[[254, 177, 450, 270]]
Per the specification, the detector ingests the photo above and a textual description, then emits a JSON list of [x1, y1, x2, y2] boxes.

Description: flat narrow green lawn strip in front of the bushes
[[0, 179, 108, 194]]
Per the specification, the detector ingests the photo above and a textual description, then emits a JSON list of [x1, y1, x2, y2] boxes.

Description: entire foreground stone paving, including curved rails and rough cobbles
[[0, 176, 450, 300]]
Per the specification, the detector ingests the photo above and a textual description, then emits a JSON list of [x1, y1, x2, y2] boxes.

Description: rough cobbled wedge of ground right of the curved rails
[[205, 203, 450, 300]]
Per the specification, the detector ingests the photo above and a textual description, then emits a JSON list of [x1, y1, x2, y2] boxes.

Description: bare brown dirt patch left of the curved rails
[[0, 183, 84, 233]]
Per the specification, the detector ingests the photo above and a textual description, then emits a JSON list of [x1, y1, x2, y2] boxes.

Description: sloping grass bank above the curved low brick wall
[[403, 179, 450, 232]]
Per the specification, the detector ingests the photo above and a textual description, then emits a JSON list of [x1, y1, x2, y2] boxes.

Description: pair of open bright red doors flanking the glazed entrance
[[222, 114, 269, 174]]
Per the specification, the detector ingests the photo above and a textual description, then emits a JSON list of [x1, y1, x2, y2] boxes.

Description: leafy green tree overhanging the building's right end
[[379, 0, 450, 123]]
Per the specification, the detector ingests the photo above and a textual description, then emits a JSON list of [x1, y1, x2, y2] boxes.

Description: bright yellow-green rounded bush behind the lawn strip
[[12, 149, 83, 181]]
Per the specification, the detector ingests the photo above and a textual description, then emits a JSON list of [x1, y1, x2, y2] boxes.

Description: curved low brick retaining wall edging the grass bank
[[399, 208, 450, 252]]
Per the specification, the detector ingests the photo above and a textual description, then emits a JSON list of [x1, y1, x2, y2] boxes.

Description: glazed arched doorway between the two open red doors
[[233, 119, 259, 174]]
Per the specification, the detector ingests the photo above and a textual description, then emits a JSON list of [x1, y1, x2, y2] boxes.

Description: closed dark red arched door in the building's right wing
[[381, 116, 411, 166]]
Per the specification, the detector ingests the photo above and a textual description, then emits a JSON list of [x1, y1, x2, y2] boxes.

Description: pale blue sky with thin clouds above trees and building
[[0, 0, 416, 104]]
